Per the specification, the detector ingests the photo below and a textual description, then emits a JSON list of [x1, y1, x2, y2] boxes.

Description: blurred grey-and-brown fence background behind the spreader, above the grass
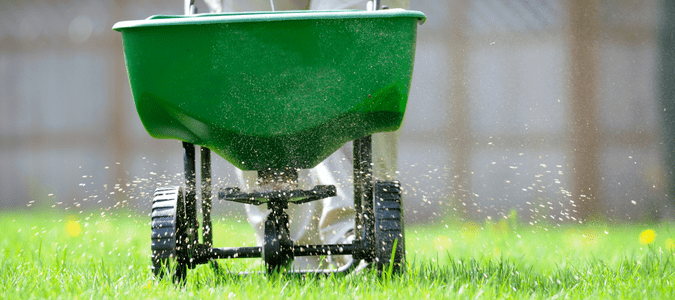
[[0, 0, 675, 223]]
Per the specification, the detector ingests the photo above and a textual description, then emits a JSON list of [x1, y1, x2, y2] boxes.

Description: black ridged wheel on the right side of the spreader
[[374, 181, 405, 273]]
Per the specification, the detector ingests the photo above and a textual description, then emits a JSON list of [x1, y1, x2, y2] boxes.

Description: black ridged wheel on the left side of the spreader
[[150, 186, 188, 281]]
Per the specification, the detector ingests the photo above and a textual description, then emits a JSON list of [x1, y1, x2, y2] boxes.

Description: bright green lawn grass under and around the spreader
[[0, 210, 675, 299]]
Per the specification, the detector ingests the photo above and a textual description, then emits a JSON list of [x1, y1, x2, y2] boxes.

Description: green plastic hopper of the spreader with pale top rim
[[113, 10, 425, 170]]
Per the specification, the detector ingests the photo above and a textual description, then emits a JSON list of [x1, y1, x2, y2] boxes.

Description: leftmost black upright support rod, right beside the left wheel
[[183, 142, 199, 243]]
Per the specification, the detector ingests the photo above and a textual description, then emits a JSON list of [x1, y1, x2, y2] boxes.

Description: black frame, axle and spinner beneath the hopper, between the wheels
[[183, 135, 375, 274]]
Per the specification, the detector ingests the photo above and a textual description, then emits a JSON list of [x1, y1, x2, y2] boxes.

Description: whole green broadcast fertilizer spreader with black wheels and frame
[[113, 9, 425, 279]]
